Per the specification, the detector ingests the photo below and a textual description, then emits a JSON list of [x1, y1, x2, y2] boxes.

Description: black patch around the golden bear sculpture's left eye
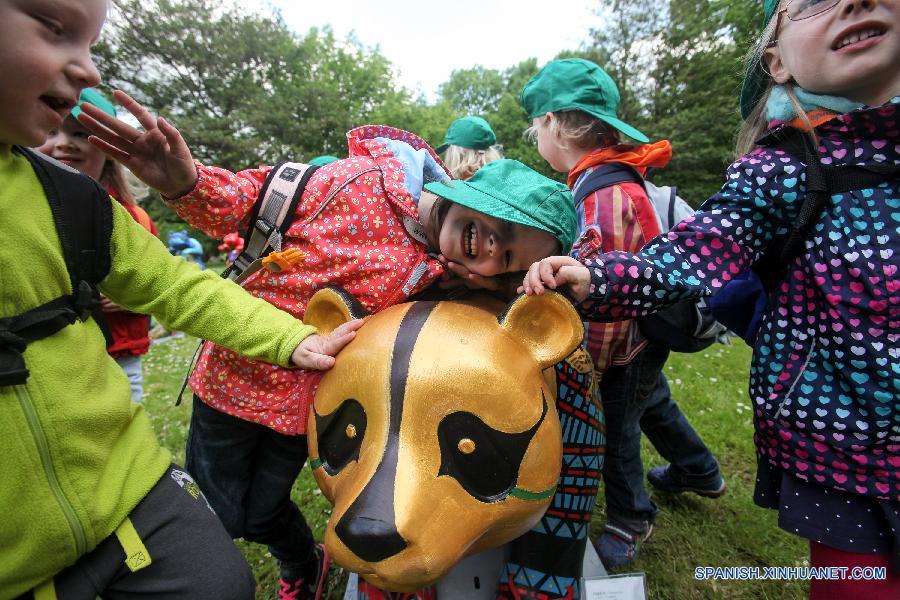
[[316, 398, 366, 475]]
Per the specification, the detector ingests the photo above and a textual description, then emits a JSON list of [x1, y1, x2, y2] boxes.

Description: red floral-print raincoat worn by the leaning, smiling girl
[[171, 126, 443, 435]]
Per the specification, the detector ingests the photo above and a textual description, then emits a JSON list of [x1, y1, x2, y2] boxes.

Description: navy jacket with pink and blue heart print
[[585, 96, 900, 501]]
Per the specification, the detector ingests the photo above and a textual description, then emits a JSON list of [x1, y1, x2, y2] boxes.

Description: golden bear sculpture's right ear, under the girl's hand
[[497, 290, 584, 369]]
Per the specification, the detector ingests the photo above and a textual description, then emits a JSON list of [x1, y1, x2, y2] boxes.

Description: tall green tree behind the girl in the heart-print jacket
[[582, 0, 761, 206]]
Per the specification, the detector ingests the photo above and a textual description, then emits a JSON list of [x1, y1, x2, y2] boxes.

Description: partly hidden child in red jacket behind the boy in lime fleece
[[37, 88, 157, 402]]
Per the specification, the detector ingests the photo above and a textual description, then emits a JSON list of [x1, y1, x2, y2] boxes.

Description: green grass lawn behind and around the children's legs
[[144, 337, 808, 600]]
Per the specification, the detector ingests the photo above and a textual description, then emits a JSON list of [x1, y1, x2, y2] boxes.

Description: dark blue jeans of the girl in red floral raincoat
[[185, 396, 315, 565]]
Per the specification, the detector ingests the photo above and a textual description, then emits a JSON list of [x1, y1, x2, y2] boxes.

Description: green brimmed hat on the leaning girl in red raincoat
[[425, 158, 578, 252]]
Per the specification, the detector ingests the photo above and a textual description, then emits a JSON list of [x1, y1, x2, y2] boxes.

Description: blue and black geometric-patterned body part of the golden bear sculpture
[[497, 350, 606, 600]]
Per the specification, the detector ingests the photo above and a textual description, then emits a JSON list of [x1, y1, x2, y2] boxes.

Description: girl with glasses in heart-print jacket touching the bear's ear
[[523, 0, 900, 600]]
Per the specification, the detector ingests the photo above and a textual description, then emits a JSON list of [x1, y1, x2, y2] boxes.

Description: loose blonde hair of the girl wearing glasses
[[735, 2, 818, 156]]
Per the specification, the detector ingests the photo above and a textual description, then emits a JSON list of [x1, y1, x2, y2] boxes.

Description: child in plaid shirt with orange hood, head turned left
[[520, 58, 725, 568]]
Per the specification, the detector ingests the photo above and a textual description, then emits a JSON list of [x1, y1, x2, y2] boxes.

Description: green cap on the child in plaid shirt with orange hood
[[519, 58, 650, 144]]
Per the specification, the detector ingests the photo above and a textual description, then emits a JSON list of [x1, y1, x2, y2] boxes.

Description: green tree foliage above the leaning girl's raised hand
[[96, 0, 396, 169]]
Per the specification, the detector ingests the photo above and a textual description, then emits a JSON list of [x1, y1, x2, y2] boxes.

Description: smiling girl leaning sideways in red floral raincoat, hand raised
[[80, 91, 575, 598]]
